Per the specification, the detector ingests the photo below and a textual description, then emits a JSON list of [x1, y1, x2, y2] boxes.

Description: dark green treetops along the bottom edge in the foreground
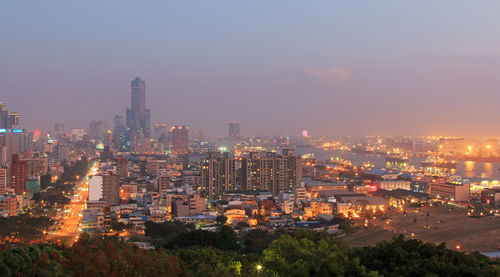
[[0, 222, 500, 276]]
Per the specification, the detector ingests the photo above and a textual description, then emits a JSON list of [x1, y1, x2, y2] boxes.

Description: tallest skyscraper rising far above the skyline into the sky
[[126, 77, 151, 147]]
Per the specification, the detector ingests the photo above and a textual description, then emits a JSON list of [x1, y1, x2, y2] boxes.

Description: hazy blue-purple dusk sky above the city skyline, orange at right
[[0, 0, 500, 137]]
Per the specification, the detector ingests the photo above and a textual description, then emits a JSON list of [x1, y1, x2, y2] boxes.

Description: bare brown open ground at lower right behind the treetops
[[344, 205, 500, 252]]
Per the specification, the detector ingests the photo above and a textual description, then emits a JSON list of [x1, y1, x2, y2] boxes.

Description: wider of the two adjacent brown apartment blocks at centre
[[241, 149, 302, 196]]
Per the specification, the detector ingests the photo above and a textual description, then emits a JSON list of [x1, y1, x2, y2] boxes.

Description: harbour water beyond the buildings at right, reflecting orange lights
[[295, 146, 500, 180]]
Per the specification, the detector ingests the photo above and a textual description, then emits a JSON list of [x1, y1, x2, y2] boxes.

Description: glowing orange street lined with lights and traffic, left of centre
[[47, 162, 99, 245]]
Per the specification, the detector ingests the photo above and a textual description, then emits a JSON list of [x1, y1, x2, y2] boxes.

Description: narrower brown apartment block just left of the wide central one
[[201, 152, 238, 199]]
